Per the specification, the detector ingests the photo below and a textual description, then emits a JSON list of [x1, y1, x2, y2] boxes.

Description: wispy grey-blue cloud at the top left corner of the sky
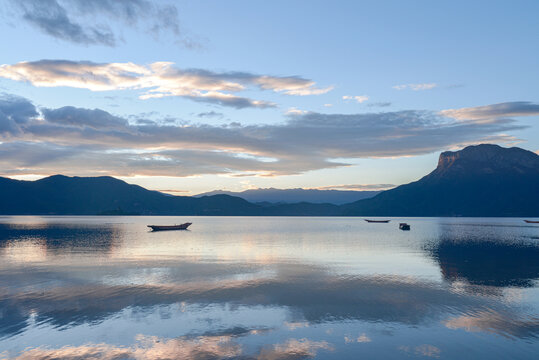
[[11, 0, 190, 47]]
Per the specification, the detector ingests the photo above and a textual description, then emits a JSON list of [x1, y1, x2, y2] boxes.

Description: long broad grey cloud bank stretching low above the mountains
[[0, 96, 525, 177]]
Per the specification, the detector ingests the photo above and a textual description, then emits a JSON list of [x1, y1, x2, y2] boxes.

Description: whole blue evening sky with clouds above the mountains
[[0, 0, 539, 195]]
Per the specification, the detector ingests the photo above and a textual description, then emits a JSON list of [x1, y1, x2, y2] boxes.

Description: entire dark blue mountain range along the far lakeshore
[[0, 144, 539, 217]]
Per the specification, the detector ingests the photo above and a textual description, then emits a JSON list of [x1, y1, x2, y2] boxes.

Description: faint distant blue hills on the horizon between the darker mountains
[[195, 188, 380, 205]]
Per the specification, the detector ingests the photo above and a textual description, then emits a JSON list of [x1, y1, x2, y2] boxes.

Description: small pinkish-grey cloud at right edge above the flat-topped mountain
[[440, 101, 539, 120]]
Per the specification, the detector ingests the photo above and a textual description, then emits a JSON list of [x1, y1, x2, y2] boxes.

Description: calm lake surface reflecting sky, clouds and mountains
[[0, 217, 539, 359]]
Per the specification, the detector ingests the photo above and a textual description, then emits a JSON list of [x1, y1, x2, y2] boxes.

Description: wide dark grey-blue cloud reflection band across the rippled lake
[[2, 264, 539, 337]]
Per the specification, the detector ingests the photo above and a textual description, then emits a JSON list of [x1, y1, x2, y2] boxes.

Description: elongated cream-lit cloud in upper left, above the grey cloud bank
[[0, 60, 330, 109]]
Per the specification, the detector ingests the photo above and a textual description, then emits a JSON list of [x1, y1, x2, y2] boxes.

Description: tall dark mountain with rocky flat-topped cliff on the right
[[343, 144, 539, 216]]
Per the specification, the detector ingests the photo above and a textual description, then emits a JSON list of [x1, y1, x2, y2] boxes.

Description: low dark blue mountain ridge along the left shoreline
[[0, 175, 259, 215]]
